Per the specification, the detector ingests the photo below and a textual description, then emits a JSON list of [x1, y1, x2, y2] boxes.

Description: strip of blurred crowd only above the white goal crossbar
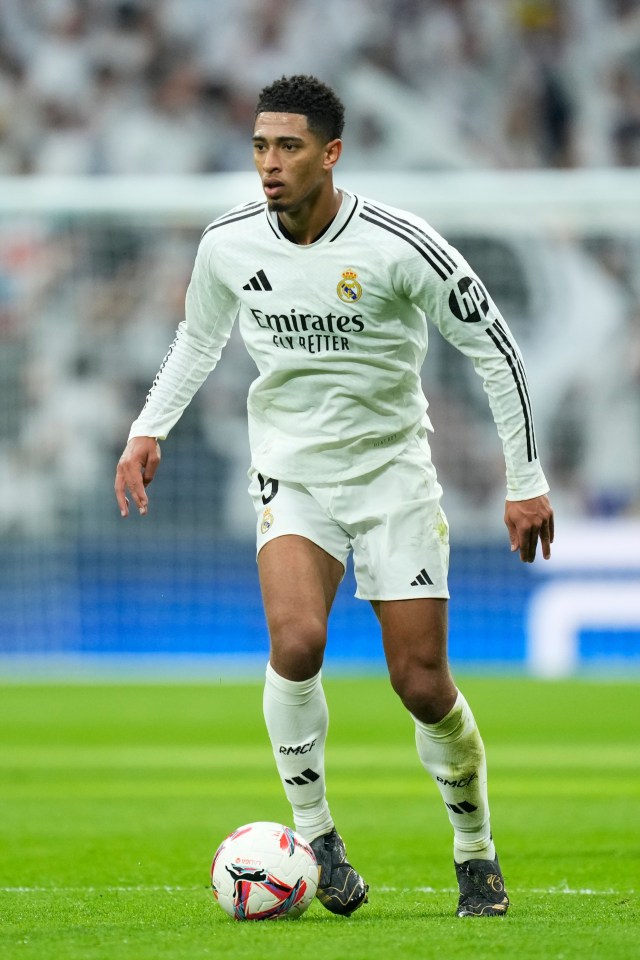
[[0, 0, 640, 174]]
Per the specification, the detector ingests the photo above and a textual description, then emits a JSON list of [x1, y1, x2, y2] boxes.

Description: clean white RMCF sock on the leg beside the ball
[[263, 663, 333, 841]]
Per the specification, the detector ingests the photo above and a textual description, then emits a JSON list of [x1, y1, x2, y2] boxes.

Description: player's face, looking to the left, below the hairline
[[253, 113, 341, 213]]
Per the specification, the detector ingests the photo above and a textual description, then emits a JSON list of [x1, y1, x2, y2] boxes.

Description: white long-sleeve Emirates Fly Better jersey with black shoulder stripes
[[130, 191, 548, 500]]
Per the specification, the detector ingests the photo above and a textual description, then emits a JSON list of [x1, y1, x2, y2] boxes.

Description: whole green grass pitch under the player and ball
[[0, 676, 640, 960]]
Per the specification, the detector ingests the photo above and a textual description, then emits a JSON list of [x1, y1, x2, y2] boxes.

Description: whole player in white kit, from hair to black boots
[[115, 76, 553, 917]]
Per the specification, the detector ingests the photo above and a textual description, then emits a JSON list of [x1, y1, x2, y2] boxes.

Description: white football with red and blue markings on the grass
[[211, 821, 320, 920]]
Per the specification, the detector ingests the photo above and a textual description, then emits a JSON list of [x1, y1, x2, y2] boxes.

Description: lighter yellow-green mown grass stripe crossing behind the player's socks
[[0, 743, 640, 806]]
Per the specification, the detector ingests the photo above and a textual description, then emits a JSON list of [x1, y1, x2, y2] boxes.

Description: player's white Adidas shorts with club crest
[[249, 427, 449, 600]]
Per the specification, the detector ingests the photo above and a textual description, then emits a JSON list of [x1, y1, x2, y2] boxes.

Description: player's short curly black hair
[[256, 73, 344, 141]]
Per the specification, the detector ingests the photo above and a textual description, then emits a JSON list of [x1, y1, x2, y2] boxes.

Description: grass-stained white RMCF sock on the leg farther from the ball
[[414, 691, 496, 863]]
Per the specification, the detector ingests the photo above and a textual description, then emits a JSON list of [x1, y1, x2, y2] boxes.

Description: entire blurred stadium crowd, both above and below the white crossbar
[[0, 0, 640, 536]]
